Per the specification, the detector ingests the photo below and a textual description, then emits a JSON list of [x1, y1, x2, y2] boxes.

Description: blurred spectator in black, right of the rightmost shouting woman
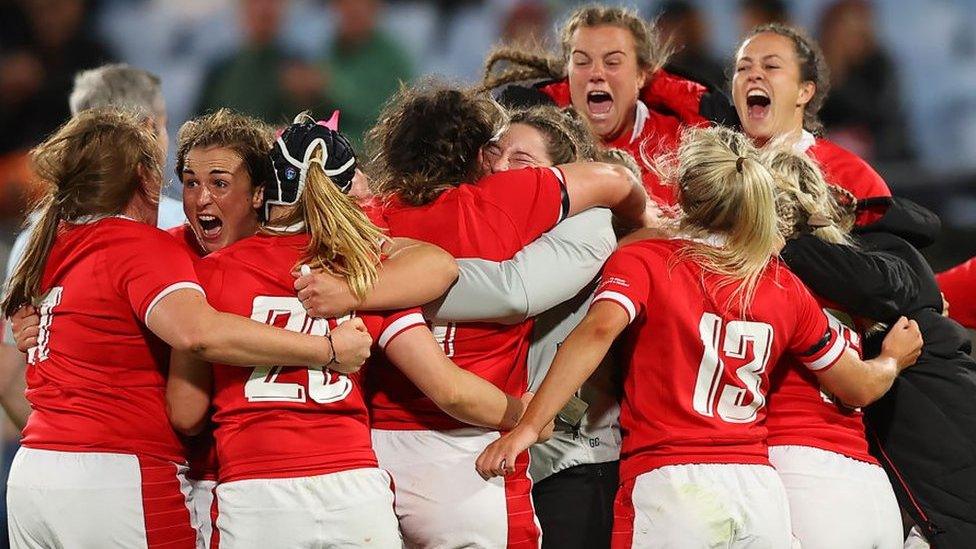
[[819, 0, 912, 161]]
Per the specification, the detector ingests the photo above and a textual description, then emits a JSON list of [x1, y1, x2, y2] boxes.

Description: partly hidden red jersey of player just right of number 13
[[766, 312, 878, 464]]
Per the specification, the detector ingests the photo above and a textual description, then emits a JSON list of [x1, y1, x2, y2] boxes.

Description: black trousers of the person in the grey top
[[532, 461, 620, 549]]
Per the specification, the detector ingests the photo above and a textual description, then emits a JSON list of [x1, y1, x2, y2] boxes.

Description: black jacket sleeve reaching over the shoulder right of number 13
[[780, 235, 919, 322]]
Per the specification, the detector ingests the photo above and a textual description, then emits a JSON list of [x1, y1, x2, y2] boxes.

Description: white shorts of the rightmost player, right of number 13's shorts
[[769, 446, 904, 549]]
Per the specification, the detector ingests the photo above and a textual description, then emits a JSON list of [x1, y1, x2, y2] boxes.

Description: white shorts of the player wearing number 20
[[217, 468, 401, 549]]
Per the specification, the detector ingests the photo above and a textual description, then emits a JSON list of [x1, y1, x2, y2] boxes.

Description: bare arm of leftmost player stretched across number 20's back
[[146, 289, 372, 373]]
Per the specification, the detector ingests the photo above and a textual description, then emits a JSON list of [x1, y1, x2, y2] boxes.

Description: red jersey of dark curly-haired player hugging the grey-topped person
[[367, 168, 569, 430]]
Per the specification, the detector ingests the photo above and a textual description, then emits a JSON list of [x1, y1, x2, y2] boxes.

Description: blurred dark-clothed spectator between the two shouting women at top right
[[657, 0, 726, 87]]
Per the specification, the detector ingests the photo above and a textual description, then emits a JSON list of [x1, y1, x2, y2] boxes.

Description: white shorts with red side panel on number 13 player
[[612, 464, 798, 549]]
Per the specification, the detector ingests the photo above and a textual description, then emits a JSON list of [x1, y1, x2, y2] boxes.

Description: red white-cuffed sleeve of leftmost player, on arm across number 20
[[112, 227, 203, 322]]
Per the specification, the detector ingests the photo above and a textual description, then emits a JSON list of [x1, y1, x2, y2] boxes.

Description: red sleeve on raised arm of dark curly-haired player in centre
[[477, 168, 569, 245]]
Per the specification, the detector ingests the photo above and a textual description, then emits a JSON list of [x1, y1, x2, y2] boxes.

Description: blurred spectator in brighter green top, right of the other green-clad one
[[290, 0, 413, 147]]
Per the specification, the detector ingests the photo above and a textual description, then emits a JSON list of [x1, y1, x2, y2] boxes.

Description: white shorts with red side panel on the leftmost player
[[7, 447, 197, 549]]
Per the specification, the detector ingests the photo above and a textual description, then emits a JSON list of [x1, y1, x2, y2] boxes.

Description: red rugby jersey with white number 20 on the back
[[198, 234, 424, 482]]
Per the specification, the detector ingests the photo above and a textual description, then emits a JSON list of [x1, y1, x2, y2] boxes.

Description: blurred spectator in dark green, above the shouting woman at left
[[196, 0, 315, 124]]
